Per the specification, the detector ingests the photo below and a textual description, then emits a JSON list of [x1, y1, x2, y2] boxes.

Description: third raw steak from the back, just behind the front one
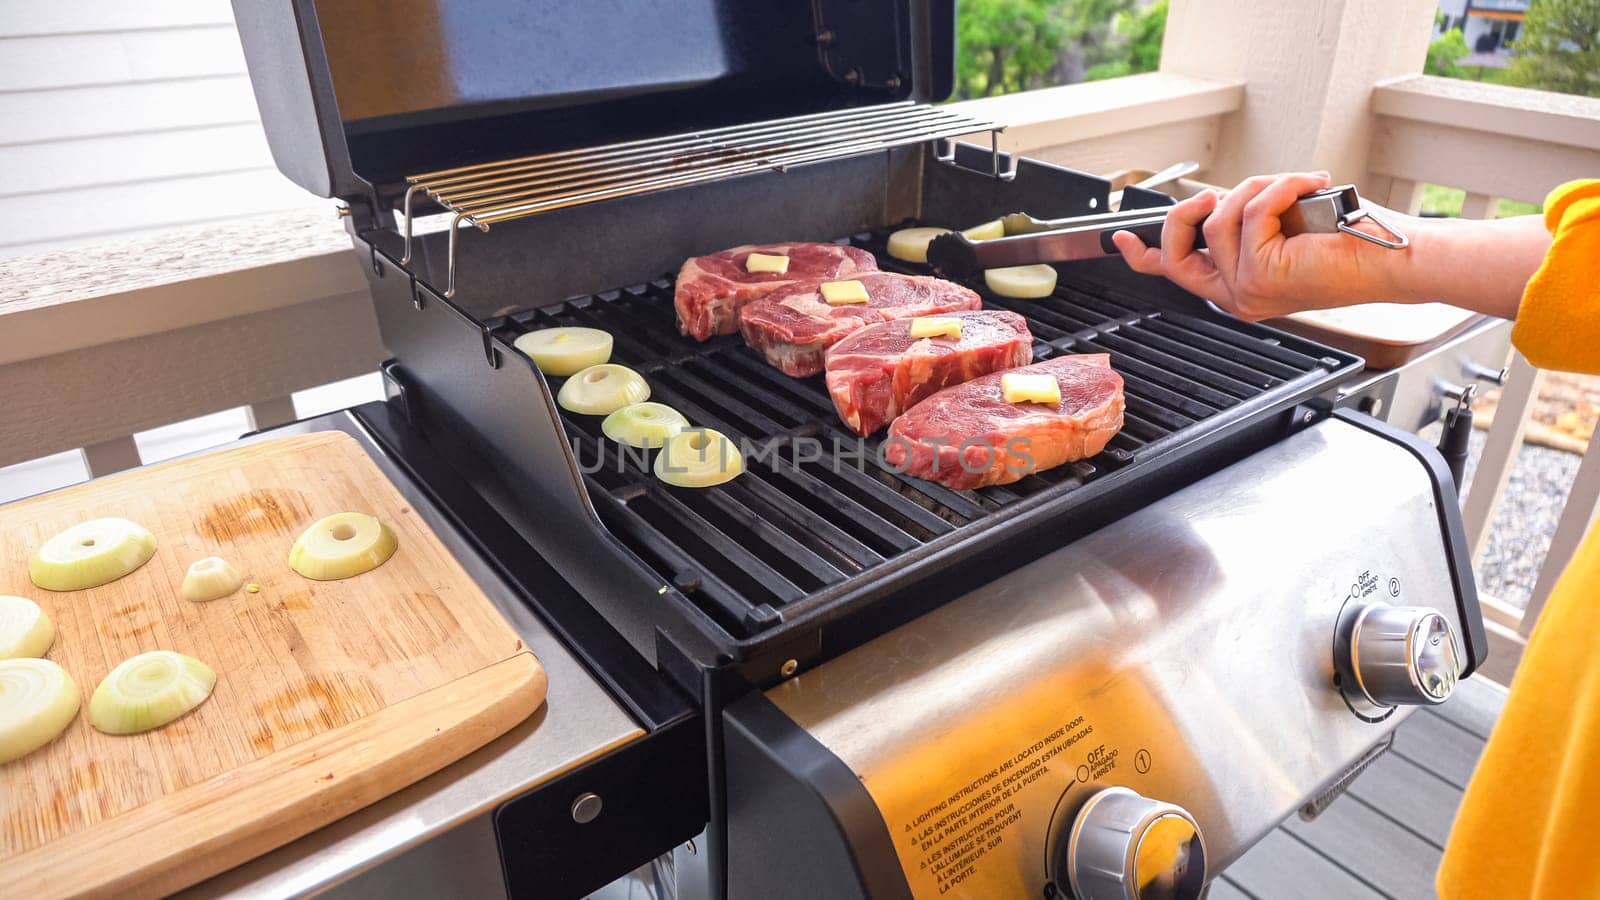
[[827, 309, 1034, 434]]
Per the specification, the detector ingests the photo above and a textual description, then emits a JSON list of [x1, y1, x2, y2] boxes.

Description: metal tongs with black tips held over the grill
[[928, 184, 1411, 277]]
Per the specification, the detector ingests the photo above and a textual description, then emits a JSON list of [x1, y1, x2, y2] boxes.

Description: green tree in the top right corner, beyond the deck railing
[[1506, 0, 1600, 96]]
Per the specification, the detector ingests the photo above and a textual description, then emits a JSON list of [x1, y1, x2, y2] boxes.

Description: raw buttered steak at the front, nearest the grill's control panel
[[883, 354, 1123, 490]]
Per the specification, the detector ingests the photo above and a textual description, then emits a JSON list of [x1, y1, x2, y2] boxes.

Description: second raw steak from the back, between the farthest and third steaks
[[739, 272, 982, 378]]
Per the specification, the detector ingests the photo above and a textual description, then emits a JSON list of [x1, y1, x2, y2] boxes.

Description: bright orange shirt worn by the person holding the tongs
[[1437, 181, 1600, 900]]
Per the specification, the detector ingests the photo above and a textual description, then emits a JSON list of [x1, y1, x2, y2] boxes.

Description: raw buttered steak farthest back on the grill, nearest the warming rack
[[672, 243, 878, 341]]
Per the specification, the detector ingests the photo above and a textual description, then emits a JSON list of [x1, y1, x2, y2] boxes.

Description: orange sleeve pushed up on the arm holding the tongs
[[1510, 179, 1600, 373]]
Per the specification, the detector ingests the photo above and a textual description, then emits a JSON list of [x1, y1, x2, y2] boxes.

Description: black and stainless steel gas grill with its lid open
[[235, 0, 1485, 900]]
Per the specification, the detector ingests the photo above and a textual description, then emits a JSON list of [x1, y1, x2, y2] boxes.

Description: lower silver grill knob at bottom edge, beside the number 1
[[1051, 788, 1205, 900]]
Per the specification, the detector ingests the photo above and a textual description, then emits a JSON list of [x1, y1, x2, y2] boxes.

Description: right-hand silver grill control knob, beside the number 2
[[1334, 604, 1461, 713]]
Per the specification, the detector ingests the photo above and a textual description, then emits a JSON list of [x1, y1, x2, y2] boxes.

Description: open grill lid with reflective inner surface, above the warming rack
[[234, 0, 955, 199]]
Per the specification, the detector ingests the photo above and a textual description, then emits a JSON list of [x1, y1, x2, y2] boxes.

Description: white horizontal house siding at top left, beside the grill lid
[[0, 0, 326, 256]]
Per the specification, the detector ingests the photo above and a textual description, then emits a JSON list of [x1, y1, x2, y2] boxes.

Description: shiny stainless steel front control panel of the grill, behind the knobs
[[730, 420, 1464, 897]]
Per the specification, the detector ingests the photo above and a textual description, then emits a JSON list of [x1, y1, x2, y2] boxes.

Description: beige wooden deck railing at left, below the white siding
[[0, 203, 384, 476]]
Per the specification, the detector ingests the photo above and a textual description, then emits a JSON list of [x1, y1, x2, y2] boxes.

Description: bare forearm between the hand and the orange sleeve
[[1386, 216, 1550, 319]]
